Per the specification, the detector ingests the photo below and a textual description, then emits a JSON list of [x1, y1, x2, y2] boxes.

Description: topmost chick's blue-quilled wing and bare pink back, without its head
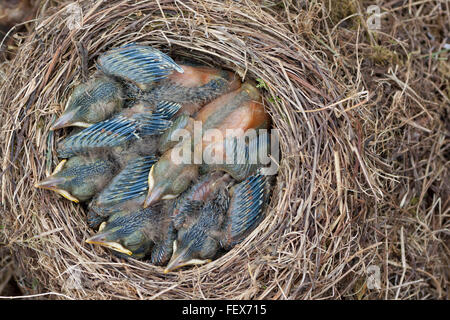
[[98, 43, 241, 111]]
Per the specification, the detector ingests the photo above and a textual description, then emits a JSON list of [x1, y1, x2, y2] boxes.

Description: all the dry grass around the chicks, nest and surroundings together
[[0, 0, 450, 299]]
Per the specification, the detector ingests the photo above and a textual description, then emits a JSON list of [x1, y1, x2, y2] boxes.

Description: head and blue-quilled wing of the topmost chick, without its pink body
[[51, 44, 179, 130]]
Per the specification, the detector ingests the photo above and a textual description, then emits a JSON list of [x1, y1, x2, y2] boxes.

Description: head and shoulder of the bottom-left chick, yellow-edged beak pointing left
[[86, 199, 175, 265]]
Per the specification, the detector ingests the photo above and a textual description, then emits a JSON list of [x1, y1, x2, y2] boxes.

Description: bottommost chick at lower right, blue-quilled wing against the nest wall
[[164, 173, 268, 273]]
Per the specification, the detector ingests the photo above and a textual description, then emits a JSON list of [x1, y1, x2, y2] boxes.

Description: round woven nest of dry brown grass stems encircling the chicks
[[0, 0, 448, 299]]
